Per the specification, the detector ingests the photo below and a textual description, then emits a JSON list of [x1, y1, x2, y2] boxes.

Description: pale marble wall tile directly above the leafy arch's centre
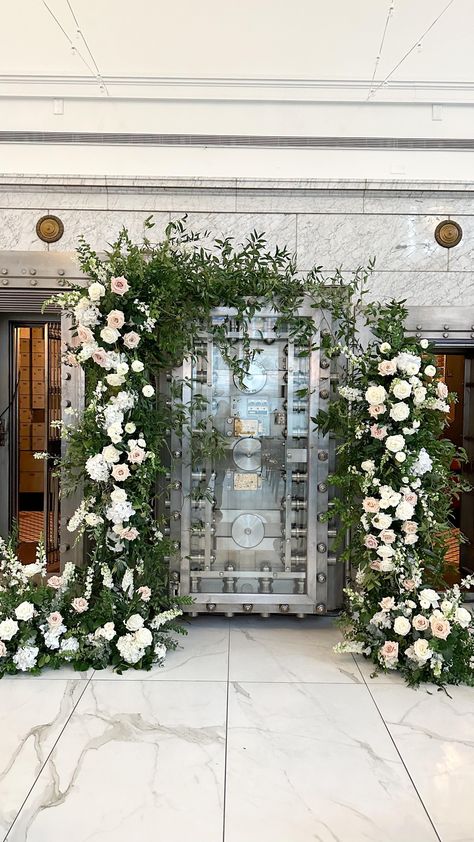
[[178, 213, 296, 252]]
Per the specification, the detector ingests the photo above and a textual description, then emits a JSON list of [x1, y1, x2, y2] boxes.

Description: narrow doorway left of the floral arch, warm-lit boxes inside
[[8, 320, 61, 572]]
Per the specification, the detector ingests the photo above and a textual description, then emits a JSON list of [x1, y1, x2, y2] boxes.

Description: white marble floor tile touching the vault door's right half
[[229, 617, 362, 684]]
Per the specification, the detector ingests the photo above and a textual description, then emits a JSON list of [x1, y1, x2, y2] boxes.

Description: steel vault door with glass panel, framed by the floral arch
[[165, 308, 343, 616]]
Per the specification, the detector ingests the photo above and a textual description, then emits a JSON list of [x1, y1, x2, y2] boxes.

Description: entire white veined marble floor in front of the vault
[[0, 617, 474, 842]]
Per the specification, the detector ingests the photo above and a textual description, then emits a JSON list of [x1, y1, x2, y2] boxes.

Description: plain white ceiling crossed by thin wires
[[0, 0, 474, 86]]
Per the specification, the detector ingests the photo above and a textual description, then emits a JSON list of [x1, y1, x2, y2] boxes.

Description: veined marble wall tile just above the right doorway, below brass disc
[[367, 270, 474, 307]]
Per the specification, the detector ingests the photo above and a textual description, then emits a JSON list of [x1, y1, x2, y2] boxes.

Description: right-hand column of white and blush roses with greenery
[[319, 301, 474, 685]]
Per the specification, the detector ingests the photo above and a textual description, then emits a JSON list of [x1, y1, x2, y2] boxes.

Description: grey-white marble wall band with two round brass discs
[[0, 176, 474, 306]]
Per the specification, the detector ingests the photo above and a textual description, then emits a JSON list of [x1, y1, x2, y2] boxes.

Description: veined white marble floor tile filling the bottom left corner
[[0, 676, 86, 839]]
